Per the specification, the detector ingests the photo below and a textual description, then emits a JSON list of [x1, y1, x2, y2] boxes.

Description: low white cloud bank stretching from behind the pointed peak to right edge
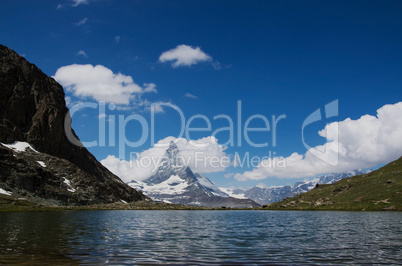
[[101, 102, 402, 182]]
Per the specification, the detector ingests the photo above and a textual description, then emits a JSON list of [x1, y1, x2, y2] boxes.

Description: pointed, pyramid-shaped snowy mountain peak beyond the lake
[[129, 141, 258, 208]]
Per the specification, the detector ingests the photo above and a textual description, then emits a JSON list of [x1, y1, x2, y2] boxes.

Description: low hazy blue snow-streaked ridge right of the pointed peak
[[220, 170, 365, 205]]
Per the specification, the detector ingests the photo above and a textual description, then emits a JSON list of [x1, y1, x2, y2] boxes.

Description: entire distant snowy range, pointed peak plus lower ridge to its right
[[128, 141, 365, 208]]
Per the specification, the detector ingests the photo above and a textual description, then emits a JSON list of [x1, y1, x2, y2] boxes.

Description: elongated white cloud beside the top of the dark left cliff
[[53, 64, 156, 105]]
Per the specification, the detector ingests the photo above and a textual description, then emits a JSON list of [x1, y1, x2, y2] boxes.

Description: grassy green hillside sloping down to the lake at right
[[268, 157, 402, 211]]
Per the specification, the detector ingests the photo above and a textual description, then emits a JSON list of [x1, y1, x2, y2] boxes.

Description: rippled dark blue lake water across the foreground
[[0, 211, 402, 264]]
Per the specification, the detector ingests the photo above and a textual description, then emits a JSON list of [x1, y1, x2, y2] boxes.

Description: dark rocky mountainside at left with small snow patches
[[0, 45, 146, 205]]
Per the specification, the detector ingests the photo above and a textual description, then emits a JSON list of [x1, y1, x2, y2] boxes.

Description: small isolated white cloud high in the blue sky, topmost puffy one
[[159, 44, 212, 67]]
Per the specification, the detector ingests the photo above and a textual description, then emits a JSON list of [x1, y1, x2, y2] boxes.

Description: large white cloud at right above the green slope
[[235, 102, 402, 181]]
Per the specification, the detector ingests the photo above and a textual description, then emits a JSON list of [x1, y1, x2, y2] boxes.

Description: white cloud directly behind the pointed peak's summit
[[101, 137, 230, 182]]
